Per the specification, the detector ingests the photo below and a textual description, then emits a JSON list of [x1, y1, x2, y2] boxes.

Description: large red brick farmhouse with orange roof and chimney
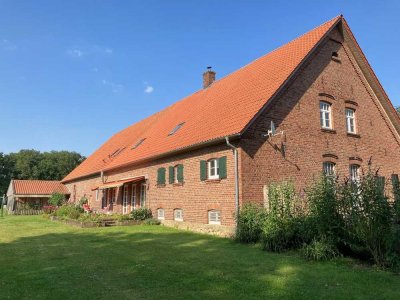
[[62, 16, 400, 232]]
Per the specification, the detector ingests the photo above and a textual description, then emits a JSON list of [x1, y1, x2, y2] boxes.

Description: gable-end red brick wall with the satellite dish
[[240, 31, 400, 202]]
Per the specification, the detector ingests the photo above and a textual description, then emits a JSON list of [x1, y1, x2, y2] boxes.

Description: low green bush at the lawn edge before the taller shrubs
[[300, 238, 339, 261]]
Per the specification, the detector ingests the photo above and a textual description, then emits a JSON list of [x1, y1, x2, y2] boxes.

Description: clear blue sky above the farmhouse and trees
[[0, 0, 400, 155]]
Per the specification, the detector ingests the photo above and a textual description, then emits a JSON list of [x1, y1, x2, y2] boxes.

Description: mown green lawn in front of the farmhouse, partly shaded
[[0, 216, 400, 299]]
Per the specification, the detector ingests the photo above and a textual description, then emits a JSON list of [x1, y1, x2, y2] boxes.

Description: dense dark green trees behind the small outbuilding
[[0, 150, 85, 195]]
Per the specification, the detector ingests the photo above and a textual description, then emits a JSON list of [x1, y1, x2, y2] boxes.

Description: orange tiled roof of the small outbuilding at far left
[[12, 180, 69, 195]]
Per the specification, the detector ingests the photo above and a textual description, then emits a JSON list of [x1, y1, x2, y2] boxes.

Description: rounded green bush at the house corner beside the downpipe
[[235, 203, 266, 243]]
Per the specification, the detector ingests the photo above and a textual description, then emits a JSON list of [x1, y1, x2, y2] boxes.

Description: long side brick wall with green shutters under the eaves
[[66, 145, 235, 226]]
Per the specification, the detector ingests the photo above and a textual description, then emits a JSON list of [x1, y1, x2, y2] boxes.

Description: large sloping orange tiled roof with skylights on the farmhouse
[[63, 16, 342, 182]]
